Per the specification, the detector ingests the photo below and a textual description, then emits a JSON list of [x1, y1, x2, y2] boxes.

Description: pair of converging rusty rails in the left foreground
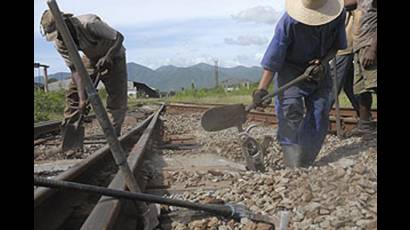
[[34, 106, 163, 229]]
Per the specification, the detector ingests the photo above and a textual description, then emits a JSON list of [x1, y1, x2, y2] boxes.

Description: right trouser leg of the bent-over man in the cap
[[101, 54, 128, 136]]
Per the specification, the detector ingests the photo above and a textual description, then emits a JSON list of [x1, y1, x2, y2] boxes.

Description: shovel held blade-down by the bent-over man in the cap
[[61, 71, 105, 152]]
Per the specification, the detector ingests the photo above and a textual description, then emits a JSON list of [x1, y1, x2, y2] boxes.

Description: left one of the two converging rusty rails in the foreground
[[34, 111, 154, 229]]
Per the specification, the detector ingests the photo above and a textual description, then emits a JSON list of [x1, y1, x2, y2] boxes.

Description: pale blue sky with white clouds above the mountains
[[34, 0, 284, 75]]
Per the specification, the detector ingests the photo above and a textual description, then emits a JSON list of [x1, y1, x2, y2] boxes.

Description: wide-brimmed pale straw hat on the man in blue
[[285, 0, 344, 26]]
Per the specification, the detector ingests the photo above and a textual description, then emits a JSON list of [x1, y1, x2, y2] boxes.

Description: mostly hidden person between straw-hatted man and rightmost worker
[[330, 0, 359, 116]]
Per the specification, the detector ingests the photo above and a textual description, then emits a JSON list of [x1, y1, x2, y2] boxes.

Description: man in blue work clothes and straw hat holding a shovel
[[253, 0, 347, 167]]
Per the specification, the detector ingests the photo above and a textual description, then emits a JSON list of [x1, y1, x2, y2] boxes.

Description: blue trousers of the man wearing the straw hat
[[275, 65, 332, 161]]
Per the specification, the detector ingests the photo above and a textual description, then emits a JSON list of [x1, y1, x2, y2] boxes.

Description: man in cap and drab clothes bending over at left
[[40, 10, 127, 136]]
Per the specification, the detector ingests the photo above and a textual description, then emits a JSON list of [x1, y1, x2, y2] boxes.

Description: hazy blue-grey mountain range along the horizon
[[34, 62, 263, 91]]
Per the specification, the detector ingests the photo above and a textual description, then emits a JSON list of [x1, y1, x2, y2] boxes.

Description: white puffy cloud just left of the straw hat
[[232, 6, 280, 25]]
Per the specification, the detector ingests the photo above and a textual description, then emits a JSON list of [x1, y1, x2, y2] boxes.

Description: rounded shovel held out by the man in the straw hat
[[201, 65, 318, 132]]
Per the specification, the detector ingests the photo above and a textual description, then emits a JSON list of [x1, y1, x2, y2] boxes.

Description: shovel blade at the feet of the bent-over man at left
[[62, 124, 84, 152]]
